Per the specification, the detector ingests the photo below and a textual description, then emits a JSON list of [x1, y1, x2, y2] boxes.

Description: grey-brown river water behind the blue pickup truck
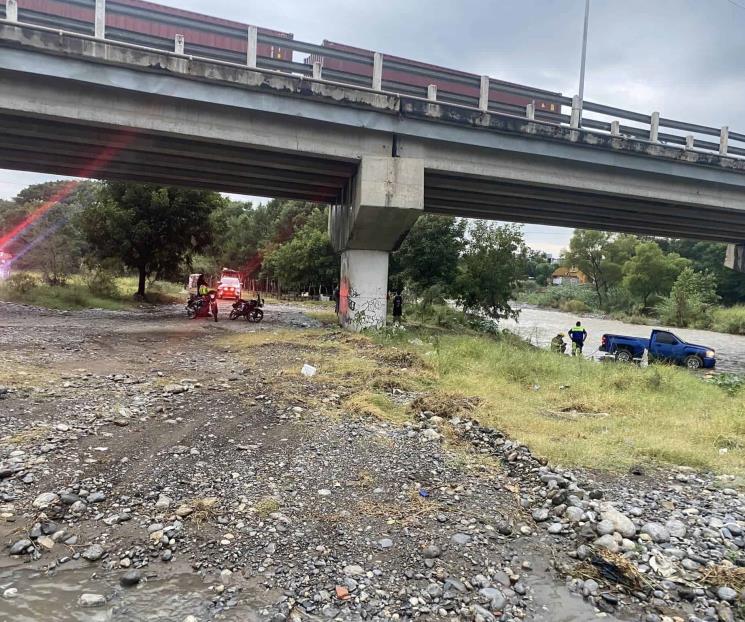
[[500, 307, 745, 373]]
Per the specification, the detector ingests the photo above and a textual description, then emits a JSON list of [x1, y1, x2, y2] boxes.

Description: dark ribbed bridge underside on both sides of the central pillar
[[0, 113, 745, 242]]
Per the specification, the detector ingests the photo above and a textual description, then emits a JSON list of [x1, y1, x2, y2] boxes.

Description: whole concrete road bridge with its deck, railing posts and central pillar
[[0, 19, 745, 328]]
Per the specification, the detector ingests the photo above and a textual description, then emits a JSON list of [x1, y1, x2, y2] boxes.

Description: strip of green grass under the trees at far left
[[0, 275, 184, 311]]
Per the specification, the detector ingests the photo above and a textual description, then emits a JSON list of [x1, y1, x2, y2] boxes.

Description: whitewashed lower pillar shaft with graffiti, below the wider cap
[[339, 250, 388, 331]]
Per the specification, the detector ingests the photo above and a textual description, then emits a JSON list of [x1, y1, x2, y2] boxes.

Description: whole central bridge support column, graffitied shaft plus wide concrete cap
[[329, 157, 424, 331]]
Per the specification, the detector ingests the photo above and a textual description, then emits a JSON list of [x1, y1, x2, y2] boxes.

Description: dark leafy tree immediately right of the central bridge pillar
[[389, 214, 466, 296]]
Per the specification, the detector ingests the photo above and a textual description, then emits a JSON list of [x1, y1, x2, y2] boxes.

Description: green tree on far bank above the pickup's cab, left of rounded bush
[[623, 242, 691, 308]]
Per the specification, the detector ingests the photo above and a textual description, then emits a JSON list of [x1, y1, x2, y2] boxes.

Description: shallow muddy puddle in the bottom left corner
[[0, 569, 259, 622]]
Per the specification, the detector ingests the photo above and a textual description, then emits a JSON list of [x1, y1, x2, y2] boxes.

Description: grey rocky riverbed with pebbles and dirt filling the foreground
[[0, 305, 745, 622]]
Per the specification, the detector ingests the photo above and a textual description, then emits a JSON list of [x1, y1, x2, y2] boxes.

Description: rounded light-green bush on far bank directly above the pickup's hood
[[658, 267, 719, 327]]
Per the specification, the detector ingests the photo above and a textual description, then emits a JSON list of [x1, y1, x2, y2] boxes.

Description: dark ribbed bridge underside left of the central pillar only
[[0, 113, 357, 203]]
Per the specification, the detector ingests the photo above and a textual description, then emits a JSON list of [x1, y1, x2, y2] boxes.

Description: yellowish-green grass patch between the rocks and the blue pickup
[[374, 334, 745, 473]]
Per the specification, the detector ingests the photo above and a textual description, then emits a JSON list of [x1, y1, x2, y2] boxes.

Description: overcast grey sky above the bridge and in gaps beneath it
[[0, 0, 745, 252]]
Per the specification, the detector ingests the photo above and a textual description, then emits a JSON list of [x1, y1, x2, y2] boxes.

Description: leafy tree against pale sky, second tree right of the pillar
[[456, 221, 527, 319]]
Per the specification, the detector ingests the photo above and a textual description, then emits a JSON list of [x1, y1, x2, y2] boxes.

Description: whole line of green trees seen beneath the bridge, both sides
[[0, 181, 745, 324]]
